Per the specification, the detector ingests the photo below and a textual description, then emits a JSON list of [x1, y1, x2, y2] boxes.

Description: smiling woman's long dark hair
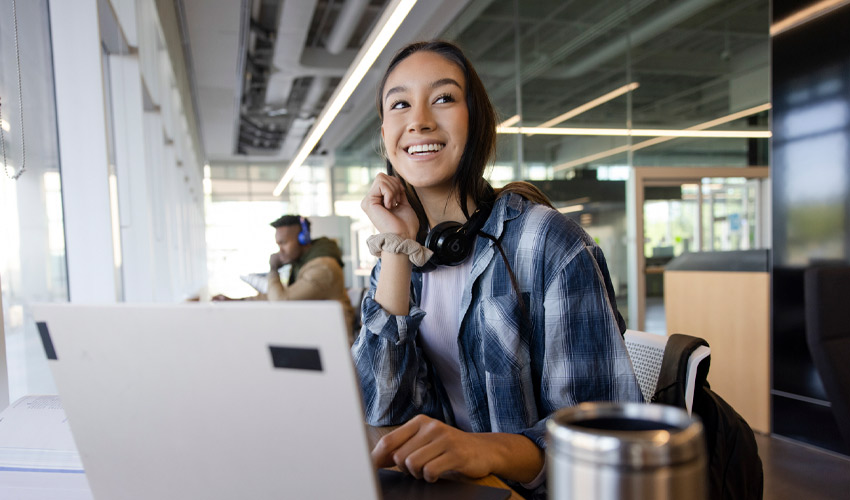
[[377, 40, 496, 239]]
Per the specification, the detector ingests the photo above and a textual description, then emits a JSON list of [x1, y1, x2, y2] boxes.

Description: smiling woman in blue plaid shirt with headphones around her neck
[[353, 41, 642, 497]]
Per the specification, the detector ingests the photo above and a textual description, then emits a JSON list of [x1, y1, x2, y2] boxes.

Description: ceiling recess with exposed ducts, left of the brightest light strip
[[237, 0, 380, 160]]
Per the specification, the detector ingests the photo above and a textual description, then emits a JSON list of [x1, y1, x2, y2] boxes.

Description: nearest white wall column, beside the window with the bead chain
[[50, 0, 118, 303]]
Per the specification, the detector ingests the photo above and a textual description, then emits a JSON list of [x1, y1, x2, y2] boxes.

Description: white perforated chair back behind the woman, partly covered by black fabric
[[624, 330, 711, 415]]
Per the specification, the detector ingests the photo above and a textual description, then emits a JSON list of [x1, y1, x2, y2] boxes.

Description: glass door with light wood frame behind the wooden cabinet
[[629, 167, 769, 334]]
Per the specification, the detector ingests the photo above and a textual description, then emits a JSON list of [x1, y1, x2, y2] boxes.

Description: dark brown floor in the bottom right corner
[[756, 433, 850, 500]]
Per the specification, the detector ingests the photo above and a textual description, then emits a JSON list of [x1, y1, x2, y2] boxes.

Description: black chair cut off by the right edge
[[804, 266, 850, 446]]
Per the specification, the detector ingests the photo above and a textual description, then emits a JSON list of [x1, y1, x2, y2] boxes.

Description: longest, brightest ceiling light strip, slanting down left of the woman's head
[[272, 0, 416, 196]]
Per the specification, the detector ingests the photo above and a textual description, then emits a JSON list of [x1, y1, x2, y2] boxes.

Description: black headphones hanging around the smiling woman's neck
[[414, 203, 493, 273]]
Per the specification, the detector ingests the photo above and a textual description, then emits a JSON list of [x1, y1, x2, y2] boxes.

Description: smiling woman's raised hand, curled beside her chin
[[360, 173, 419, 239]]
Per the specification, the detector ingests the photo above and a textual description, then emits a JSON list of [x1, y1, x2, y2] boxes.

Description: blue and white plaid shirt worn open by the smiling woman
[[352, 193, 643, 448]]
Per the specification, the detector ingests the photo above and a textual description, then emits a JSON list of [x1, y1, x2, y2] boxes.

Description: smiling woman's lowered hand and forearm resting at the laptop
[[372, 415, 543, 483]]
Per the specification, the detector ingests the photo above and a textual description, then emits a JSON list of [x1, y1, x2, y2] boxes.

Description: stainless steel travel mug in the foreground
[[546, 403, 708, 500]]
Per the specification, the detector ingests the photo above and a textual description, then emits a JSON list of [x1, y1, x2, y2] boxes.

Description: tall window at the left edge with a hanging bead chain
[[0, 0, 68, 400]]
